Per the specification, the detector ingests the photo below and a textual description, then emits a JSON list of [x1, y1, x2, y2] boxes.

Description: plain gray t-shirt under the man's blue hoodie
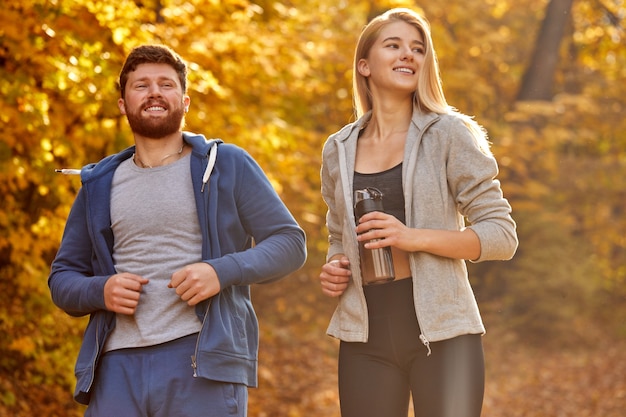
[[105, 155, 202, 351]]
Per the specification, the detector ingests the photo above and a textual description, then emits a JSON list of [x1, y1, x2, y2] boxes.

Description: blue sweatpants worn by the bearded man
[[85, 335, 248, 417]]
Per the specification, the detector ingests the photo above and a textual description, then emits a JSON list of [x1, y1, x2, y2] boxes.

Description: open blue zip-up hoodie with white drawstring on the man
[[48, 132, 306, 404]]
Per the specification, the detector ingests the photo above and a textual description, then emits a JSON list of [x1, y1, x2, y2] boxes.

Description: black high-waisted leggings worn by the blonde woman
[[339, 279, 485, 417]]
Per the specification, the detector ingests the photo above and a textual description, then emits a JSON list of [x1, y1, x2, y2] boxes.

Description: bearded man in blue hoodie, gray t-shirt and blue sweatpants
[[48, 45, 306, 417]]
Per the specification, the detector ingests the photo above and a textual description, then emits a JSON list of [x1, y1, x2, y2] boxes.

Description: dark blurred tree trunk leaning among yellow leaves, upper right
[[517, 0, 574, 101]]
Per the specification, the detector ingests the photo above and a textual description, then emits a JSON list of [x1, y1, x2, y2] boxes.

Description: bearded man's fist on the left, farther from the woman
[[104, 272, 148, 316]]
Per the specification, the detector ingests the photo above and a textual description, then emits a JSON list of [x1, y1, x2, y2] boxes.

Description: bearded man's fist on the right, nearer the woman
[[168, 262, 221, 306]]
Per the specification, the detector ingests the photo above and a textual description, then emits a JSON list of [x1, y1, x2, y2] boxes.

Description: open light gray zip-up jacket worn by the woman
[[321, 110, 518, 352]]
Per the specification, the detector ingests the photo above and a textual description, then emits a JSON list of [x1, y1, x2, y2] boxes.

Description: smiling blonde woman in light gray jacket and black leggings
[[320, 9, 518, 417]]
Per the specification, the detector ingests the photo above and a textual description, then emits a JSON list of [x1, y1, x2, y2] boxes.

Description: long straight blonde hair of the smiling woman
[[352, 8, 490, 153]]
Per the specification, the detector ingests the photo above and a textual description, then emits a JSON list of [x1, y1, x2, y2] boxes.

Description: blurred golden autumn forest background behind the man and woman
[[0, 0, 626, 417]]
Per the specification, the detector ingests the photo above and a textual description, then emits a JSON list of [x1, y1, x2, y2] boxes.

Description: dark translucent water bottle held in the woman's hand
[[354, 187, 395, 285]]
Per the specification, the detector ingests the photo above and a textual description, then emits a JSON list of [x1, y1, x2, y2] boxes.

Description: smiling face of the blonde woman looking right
[[357, 21, 425, 96]]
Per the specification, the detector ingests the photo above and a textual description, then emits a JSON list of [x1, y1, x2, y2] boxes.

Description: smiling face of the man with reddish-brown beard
[[118, 64, 189, 139]]
